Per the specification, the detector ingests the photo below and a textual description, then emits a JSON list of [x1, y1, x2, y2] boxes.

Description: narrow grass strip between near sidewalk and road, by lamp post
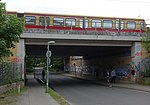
[[48, 88, 71, 105]]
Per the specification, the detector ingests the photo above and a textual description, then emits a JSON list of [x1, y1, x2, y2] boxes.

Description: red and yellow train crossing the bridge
[[8, 12, 146, 33]]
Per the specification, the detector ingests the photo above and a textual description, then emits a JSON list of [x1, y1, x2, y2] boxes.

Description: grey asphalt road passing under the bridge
[[50, 75, 150, 105]]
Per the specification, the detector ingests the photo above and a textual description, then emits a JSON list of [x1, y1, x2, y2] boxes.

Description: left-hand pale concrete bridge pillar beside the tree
[[16, 39, 25, 80]]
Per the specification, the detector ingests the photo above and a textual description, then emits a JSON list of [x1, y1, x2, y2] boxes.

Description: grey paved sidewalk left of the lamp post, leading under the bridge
[[16, 75, 59, 105]]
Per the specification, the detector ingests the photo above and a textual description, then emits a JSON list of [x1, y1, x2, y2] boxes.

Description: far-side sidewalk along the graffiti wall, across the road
[[64, 74, 150, 92]]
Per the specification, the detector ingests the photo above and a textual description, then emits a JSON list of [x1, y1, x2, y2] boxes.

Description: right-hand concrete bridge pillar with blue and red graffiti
[[131, 42, 141, 83]]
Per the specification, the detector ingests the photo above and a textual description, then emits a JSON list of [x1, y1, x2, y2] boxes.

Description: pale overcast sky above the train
[[1, 0, 150, 24]]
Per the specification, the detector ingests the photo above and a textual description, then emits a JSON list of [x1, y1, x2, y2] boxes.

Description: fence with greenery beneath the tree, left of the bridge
[[0, 62, 22, 85]]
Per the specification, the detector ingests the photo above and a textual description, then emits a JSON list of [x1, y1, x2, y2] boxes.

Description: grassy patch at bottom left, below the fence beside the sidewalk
[[0, 87, 27, 105]]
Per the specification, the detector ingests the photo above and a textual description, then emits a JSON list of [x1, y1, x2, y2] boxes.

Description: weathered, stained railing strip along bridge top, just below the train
[[24, 28, 148, 36]]
